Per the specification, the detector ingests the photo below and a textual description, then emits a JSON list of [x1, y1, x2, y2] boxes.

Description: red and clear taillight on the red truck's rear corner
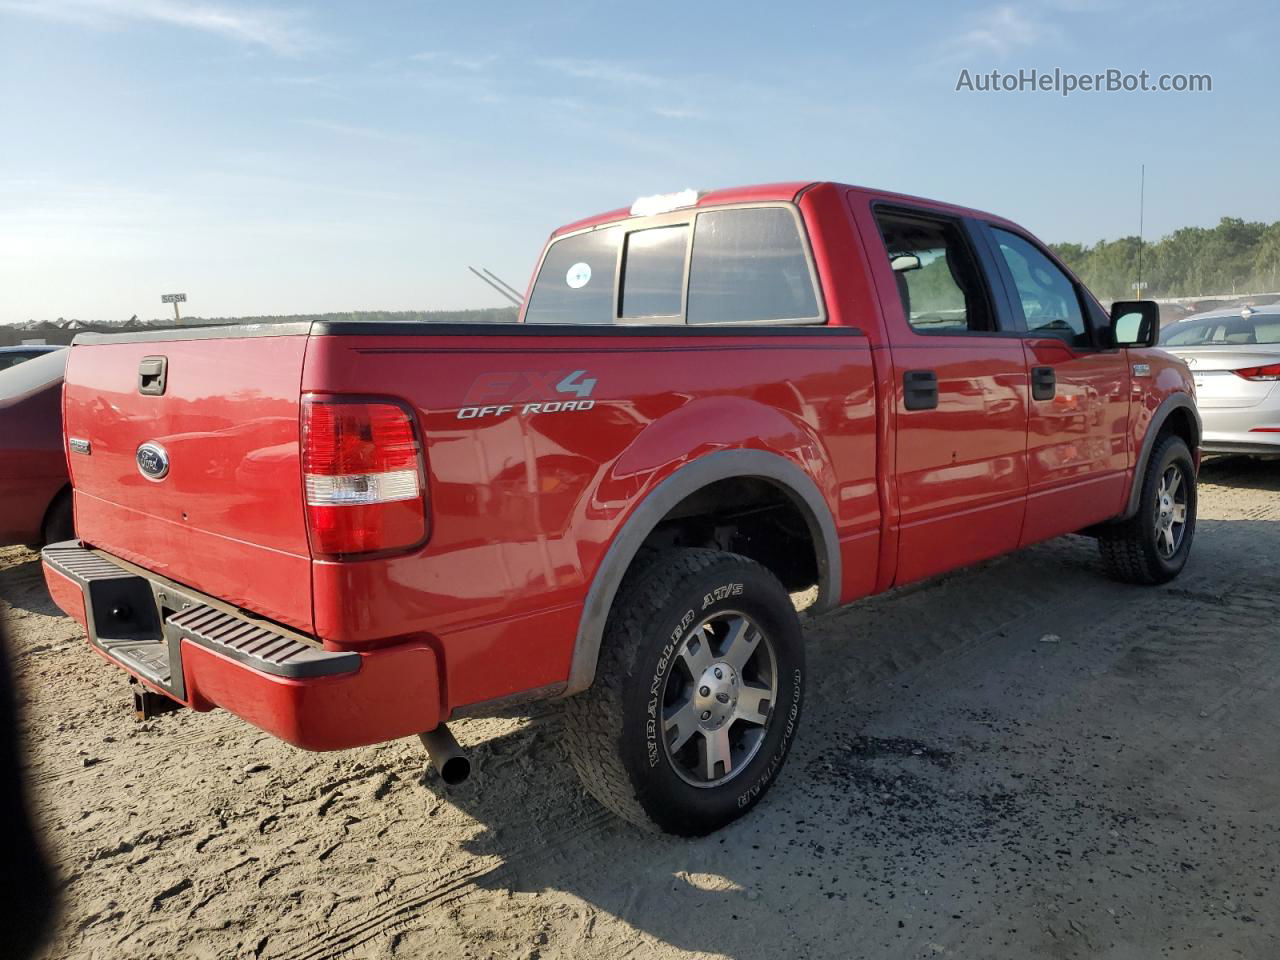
[[302, 397, 426, 557]]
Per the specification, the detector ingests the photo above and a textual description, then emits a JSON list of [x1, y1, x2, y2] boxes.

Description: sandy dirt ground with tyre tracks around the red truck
[[0, 461, 1280, 960]]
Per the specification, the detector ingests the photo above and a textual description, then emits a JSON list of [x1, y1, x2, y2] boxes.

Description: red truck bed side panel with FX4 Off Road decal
[[302, 330, 879, 708]]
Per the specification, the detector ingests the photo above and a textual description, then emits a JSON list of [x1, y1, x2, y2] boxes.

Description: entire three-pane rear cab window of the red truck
[[525, 204, 826, 324]]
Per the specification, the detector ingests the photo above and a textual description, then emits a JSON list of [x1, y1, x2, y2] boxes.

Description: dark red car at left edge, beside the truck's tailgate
[[0, 347, 74, 547]]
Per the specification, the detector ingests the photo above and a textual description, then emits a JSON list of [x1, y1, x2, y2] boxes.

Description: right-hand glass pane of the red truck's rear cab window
[[689, 207, 820, 324]]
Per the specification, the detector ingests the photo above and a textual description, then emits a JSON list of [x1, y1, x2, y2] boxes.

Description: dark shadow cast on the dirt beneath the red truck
[[407, 521, 1280, 959]]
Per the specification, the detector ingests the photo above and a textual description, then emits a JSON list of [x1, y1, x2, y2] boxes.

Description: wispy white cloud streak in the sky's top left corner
[[0, 0, 320, 55]]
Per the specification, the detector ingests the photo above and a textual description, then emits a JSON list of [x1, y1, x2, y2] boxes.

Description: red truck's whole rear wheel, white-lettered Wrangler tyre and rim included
[[566, 549, 805, 836]]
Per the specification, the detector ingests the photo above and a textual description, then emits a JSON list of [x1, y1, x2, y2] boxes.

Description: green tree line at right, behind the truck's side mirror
[[1050, 216, 1280, 300]]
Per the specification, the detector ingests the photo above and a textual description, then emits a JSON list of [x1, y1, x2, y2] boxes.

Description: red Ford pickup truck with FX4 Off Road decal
[[44, 183, 1201, 835]]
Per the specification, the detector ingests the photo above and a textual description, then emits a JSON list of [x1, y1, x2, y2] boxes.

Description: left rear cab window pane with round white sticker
[[525, 227, 622, 324]]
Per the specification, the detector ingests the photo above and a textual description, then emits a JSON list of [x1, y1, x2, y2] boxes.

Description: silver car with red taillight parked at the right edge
[[1160, 305, 1280, 454]]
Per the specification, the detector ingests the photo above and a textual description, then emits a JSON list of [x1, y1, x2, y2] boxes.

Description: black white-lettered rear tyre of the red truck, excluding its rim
[[564, 549, 805, 836]]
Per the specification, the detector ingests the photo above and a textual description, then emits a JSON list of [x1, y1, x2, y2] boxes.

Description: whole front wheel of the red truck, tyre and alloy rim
[[1098, 435, 1196, 584]]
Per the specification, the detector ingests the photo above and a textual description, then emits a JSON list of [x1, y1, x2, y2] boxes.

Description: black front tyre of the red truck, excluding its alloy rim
[[1098, 434, 1197, 585]]
